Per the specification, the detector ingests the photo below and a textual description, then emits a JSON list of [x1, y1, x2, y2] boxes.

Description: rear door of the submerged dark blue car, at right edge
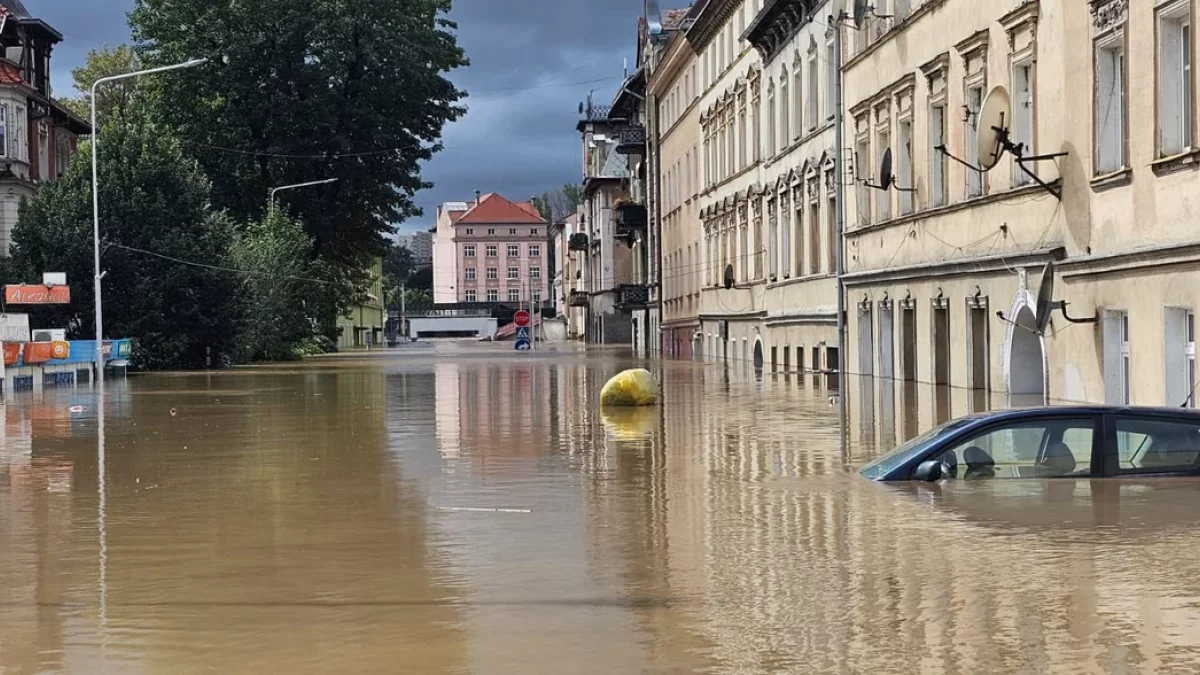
[[1104, 411, 1200, 478]]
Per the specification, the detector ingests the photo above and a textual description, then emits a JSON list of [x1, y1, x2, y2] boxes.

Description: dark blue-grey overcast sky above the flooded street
[[35, 0, 648, 231]]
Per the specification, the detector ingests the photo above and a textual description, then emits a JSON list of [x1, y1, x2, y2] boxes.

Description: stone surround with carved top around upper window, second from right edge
[[1091, 0, 1130, 172]]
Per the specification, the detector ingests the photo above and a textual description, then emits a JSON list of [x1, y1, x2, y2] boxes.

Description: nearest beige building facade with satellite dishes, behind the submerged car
[[842, 0, 1200, 437]]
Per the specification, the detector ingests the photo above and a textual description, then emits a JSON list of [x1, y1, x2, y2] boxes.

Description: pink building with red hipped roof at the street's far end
[[433, 193, 552, 305]]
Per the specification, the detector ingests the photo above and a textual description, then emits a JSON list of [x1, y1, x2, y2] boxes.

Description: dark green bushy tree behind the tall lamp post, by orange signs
[[10, 124, 241, 369]]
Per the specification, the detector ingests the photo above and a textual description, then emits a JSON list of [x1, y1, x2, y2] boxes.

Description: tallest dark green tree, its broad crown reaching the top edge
[[130, 0, 467, 263]]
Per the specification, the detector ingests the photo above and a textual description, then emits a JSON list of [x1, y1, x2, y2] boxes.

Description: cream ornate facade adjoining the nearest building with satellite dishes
[[688, 0, 838, 370]]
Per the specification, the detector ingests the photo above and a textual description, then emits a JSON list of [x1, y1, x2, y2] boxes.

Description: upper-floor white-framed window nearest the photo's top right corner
[[1158, 0, 1193, 156]]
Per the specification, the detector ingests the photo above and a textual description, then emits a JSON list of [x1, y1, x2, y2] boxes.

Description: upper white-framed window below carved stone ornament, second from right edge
[[1093, 31, 1126, 173]]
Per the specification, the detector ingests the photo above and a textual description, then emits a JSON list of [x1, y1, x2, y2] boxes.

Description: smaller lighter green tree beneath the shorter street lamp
[[232, 209, 328, 360]]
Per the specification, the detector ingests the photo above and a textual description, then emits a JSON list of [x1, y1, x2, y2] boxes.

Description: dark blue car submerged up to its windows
[[860, 406, 1200, 482]]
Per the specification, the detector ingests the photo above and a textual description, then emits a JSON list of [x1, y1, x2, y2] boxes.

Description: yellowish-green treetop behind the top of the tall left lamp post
[[62, 44, 145, 127]]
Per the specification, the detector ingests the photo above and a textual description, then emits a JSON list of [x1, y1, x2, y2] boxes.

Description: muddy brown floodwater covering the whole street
[[0, 346, 1200, 675]]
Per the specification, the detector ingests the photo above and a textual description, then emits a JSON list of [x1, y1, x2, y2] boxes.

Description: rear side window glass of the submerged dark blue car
[[1116, 417, 1200, 473]]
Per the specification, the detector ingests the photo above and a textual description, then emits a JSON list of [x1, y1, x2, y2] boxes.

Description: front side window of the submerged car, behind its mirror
[[937, 418, 1096, 479]]
